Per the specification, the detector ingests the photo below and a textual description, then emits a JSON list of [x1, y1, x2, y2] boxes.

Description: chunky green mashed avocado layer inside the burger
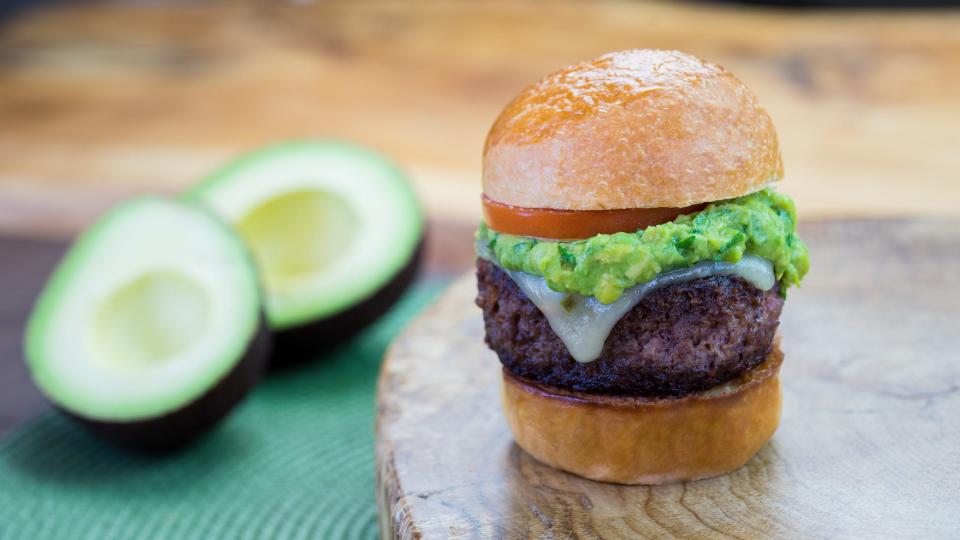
[[477, 189, 810, 304]]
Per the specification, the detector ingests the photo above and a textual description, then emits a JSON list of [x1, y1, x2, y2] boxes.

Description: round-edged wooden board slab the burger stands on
[[377, 221, 960, 538]]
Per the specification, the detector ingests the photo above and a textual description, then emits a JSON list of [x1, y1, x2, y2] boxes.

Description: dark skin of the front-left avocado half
[[67, 314, 272, 452]]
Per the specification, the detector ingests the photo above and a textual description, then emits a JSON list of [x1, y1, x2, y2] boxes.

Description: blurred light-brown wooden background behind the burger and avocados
[[0, 0, 960, 237]]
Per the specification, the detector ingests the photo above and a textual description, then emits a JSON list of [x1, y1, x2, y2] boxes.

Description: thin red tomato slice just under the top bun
[[483, 195, 707, 240]]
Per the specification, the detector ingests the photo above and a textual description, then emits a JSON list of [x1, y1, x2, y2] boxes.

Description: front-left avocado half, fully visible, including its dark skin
[[24, 197, 270, 449]]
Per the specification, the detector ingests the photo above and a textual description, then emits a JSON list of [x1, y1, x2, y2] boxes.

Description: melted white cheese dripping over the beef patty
[[505, 255, 776, 363]]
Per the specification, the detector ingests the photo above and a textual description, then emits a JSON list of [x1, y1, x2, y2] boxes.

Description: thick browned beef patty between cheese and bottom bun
[[477, 259, 783, 396]]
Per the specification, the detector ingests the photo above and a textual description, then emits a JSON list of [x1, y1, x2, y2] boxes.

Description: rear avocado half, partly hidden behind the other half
[[185, 140, 424, 364]]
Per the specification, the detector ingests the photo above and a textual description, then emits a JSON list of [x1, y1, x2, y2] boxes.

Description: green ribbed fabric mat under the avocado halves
[[0, 282, 442, 540]]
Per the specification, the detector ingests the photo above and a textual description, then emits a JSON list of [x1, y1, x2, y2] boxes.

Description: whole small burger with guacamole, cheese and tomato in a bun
[[476, 50, 808, 484]]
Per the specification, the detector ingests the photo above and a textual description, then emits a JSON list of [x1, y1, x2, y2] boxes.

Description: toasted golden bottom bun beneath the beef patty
[[503, 343, 783, 484]]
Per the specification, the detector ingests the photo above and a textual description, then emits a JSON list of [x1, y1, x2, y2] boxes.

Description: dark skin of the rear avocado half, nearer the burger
[[270, 237, 426, 368]]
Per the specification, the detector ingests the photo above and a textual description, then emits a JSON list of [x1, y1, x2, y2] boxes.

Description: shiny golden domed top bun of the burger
[[483, 49, 783, 210]]
